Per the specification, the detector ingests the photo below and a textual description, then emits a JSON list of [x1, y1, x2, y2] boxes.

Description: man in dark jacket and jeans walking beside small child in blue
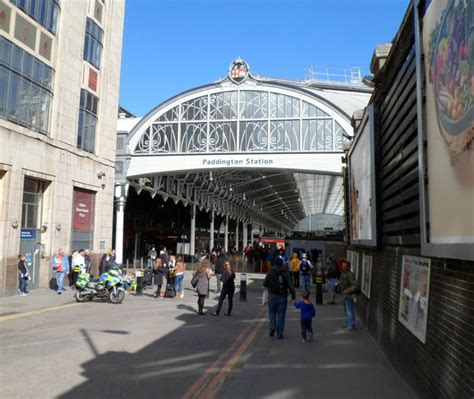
[[263, 258, 296, 339]]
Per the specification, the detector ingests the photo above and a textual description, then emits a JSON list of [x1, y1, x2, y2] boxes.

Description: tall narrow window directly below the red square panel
[[77, 89, 99, 153]]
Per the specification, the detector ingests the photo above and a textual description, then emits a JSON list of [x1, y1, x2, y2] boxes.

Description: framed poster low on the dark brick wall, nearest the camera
[[398, 255, 430, 343]]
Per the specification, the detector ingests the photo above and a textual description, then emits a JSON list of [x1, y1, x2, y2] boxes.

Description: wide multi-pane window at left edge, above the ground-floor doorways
[[0, 37, 54, 134]]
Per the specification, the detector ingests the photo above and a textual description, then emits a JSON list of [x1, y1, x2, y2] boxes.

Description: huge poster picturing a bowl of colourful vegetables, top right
[[422, 0, 474, 244]]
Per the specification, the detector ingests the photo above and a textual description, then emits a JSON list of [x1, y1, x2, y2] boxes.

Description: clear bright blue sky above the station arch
[[120, 0, 409, 116]]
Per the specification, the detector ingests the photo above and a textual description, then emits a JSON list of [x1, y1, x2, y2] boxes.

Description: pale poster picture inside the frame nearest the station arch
[[350, 115, 372, 240]]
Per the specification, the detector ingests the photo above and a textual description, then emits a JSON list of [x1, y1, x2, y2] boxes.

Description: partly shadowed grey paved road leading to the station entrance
[[0, 272, 416, 399]]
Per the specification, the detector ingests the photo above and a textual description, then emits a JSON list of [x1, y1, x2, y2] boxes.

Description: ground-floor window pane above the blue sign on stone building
[[21, 177, 43, 229]]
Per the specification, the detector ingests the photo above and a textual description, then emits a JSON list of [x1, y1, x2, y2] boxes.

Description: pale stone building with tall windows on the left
[[0, 0, 125, 296]]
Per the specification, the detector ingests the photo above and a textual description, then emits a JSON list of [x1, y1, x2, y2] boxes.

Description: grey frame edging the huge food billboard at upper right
[[414, 0, 474, 261]]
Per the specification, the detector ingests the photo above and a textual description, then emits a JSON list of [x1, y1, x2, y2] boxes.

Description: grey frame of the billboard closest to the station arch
[[348, 104, 378, 247]]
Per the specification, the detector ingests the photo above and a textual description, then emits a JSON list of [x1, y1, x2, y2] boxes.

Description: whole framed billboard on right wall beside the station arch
[[349, 105, 377, 246]]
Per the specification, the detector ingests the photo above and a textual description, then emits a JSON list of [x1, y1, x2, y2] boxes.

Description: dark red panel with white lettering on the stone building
[[71, 187, 95, 250]]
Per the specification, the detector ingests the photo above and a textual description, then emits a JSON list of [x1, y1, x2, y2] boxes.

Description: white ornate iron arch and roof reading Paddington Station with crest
[[115, 59, 369, 261]]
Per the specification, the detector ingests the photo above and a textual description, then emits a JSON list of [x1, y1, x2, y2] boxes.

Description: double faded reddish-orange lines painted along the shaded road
[[182, 309, 265, 399]]
